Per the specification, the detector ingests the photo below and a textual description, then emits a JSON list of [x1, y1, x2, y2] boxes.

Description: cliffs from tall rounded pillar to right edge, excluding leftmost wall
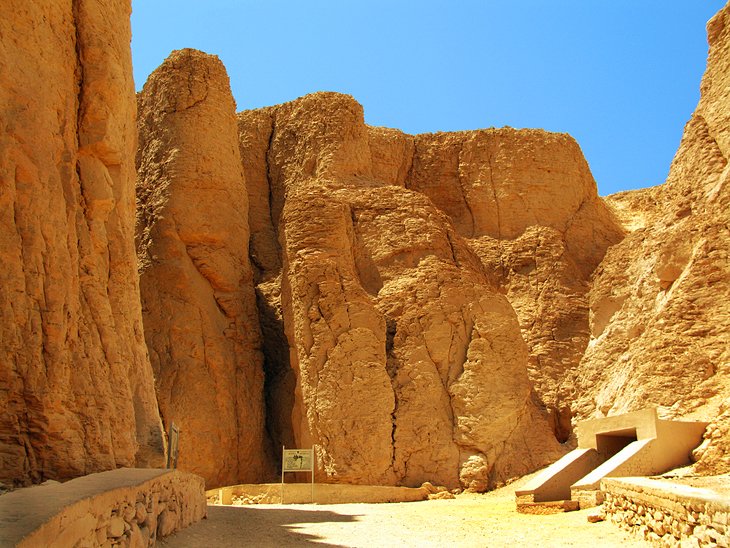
[[128, 1, 730, 490]]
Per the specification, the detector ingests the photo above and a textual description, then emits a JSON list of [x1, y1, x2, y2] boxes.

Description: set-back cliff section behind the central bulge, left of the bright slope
[[406, 128, 623, 441]]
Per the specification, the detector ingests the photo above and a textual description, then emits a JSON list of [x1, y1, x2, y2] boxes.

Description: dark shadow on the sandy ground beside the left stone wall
[[158, 506, 358, 548]]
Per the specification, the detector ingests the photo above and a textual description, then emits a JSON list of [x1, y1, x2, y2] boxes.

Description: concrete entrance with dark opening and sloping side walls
[[515, 408, 707, 510]]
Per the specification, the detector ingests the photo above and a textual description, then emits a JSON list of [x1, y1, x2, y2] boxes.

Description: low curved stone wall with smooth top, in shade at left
[[0, 468, 206, 548]]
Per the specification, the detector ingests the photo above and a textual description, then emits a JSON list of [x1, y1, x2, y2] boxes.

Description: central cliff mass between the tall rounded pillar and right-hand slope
[[230, 93, 623, 489]]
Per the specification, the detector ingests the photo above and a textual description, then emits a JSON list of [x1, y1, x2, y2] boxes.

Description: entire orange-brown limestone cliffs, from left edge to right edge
[[0, 0, 730, 491]]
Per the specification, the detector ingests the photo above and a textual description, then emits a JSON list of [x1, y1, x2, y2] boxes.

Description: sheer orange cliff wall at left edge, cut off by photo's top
[[0, 0, 163, 483]]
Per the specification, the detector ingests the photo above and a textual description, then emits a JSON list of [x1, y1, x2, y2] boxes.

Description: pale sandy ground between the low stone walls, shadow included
[[159, 484, 647, 548]]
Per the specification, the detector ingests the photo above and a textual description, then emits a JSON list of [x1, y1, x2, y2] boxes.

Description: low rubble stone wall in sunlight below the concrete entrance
[[601, 478, 730, 548]]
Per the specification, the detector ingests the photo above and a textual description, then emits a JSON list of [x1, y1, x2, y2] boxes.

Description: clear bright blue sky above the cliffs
[[132, 0, 725, 195]]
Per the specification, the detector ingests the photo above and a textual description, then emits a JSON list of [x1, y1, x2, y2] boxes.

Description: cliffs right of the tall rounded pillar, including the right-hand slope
[[158, 22, 728, 480]]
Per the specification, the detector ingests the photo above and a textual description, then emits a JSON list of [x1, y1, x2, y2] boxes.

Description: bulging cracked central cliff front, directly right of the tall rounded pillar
[[233, 93, 560, 490]]
